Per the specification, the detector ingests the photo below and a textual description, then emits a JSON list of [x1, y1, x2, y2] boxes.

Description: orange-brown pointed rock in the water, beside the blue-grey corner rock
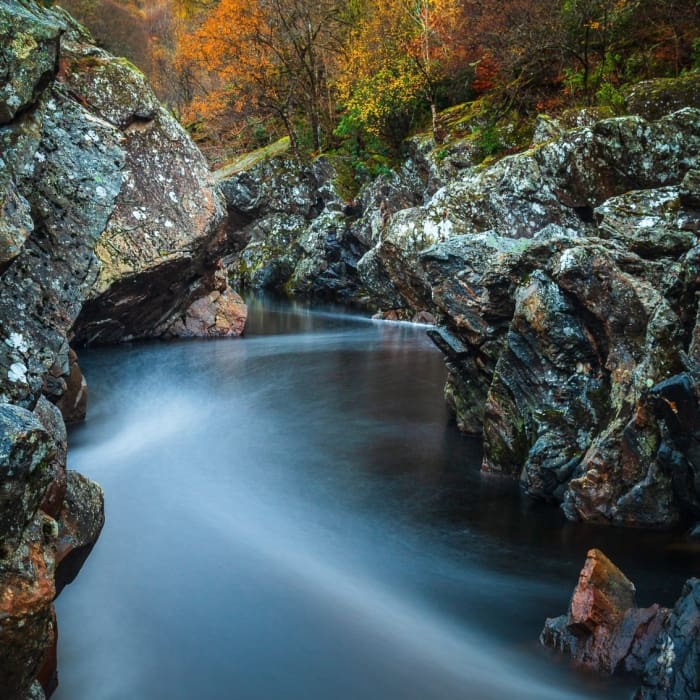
[[540, 549, 670, 674]]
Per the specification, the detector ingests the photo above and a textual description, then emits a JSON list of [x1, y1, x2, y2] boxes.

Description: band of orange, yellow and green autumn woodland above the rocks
[[54, 0, 700, 165]]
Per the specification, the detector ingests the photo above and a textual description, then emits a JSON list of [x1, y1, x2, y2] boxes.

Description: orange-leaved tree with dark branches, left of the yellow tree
[[180, 0, 342, 158]]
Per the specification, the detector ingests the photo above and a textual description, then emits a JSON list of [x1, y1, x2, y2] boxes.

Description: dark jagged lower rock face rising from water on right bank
[[420, 206, 697, 527]]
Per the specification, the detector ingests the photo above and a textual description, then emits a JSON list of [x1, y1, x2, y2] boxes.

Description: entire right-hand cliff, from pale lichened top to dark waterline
[[418, 109, 700, 527]]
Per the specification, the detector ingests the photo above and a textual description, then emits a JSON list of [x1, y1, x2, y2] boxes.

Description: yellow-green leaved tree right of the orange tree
[[338, 0, 464, 140]]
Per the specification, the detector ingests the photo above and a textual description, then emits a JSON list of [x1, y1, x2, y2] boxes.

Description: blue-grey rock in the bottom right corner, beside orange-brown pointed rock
[[634, 578, 700, 700]]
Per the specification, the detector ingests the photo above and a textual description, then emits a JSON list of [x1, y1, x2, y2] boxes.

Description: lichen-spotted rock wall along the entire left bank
[[0, 0, 245, 700]]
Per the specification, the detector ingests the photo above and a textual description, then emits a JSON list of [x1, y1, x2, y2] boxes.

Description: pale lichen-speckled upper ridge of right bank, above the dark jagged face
[[360, 108, 700, 320]]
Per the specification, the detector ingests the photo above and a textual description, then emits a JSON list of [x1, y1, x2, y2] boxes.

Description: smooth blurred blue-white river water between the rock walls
[[54, 299, 688, 700]]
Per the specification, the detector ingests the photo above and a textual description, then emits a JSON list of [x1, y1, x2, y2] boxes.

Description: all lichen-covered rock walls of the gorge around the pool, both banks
[[0, 0, 700, 700]]
